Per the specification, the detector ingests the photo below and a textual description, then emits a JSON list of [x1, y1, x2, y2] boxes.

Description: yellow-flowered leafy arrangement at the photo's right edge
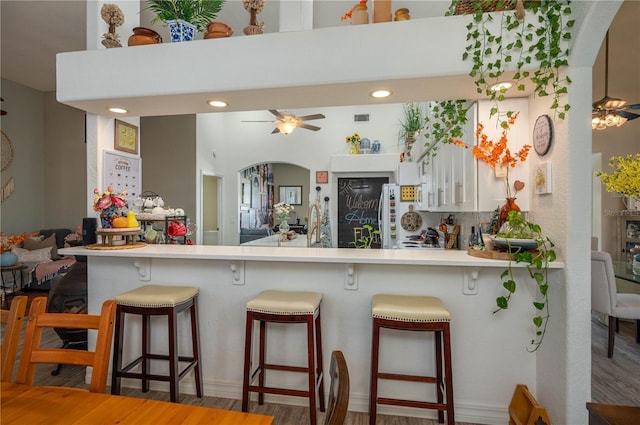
[[595, 153, 640, 199]]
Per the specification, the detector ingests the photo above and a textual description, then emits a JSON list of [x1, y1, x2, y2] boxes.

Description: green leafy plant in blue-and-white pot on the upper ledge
[[148, 0, 225, 41]]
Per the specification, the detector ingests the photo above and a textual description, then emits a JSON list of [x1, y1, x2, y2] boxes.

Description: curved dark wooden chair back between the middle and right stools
[[324, 351, 349, 425]]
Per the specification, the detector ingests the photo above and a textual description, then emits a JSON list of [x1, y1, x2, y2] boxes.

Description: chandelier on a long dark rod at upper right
[[591, 31, 640, 130]]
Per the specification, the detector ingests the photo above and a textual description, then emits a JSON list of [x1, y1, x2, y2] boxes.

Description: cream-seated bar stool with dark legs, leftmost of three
[[111, 285, 202, 403]]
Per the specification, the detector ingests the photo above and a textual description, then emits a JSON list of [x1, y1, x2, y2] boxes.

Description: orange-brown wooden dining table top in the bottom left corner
[[0, 382, 273, 425]]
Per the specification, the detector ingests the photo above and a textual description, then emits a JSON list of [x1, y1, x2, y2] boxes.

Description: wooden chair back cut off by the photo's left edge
[[0, 296, 27, 382]]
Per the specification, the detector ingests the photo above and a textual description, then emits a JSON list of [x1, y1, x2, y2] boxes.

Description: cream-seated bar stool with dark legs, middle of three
[[242, 290, 325, 425]]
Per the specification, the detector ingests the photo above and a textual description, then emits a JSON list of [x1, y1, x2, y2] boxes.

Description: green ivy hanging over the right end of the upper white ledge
[[447, 0, 575, 123]]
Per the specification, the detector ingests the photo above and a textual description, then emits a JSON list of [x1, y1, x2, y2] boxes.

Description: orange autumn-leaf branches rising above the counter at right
[[451, 112, 531, 198]]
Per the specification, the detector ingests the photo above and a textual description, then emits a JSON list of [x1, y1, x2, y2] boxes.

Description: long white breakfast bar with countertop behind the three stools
[[60, 245, 564, 424]]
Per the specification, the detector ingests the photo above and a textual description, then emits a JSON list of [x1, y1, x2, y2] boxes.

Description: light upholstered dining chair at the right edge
[[591, 251, 640, 358]]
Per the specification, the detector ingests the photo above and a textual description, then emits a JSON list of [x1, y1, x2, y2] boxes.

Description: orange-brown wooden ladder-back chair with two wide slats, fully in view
[[16, 297, 116, 393]]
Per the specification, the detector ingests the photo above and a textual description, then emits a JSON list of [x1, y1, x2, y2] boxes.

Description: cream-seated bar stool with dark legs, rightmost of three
[[369, 294, 455, 425]]
